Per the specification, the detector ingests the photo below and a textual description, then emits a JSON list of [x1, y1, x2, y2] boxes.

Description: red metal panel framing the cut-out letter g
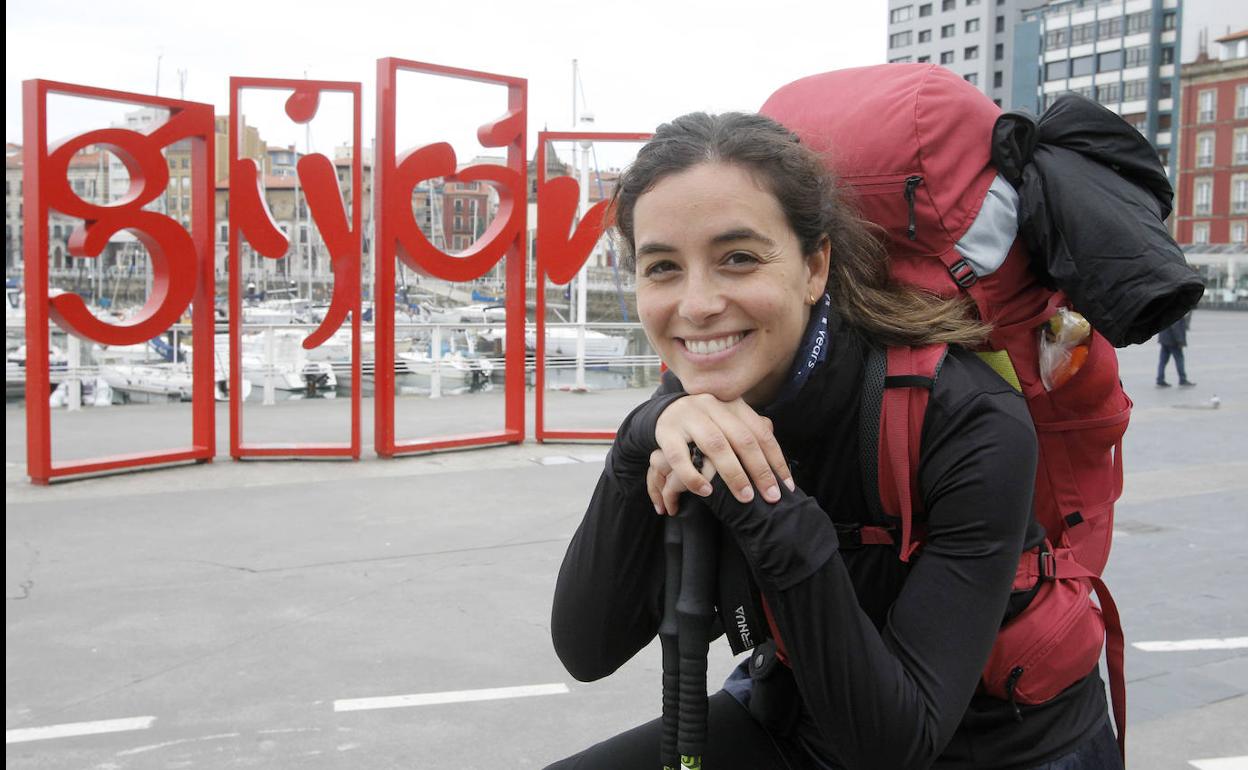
[[22, 80, 216, 484]]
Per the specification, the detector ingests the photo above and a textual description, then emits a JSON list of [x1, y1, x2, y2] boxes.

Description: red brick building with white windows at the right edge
[[1174, 30, 1248, 243]]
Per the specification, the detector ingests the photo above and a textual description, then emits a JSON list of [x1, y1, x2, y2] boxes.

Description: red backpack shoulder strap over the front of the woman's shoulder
[[860, 344, 948, 562]]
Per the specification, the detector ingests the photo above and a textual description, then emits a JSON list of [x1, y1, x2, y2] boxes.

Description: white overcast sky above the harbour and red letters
[[5, 0, 1248, 165]]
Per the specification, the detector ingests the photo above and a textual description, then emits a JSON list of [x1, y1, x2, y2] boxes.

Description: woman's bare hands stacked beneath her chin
[[645, 394, 794, 515]]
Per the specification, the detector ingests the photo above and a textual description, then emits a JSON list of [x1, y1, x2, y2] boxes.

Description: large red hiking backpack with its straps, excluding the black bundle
[[761, 65, 1131, 748]]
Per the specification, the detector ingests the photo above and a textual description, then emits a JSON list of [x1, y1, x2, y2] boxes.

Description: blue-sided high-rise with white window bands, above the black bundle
[[1008, 0, 1182, 176]]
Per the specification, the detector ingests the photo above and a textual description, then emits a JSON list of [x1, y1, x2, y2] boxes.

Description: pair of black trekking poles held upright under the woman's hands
[[659, 447, 718, 770]]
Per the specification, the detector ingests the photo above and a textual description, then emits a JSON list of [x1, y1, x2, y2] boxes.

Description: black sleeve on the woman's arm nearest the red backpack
[[711, 366, 1037, 769]]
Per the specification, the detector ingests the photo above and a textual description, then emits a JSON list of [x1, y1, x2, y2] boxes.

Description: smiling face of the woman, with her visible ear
[[633, 162, 827, 407]]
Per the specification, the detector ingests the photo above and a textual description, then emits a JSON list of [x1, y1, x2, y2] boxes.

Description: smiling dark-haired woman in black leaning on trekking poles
[[552, 114, 1121, 769]]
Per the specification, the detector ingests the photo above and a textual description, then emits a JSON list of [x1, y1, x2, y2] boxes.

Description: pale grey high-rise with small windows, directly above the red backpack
[[889, 0, 1021, 109]]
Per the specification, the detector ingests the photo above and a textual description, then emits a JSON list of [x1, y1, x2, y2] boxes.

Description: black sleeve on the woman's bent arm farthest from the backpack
[[550, 378, 684, 681]]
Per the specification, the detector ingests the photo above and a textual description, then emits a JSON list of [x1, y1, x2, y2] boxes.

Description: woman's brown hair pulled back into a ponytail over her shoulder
[[612, 112, 991, 347]]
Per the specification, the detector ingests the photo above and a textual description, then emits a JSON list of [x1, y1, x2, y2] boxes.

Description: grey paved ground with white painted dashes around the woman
[[5, 313, 1248, 770]]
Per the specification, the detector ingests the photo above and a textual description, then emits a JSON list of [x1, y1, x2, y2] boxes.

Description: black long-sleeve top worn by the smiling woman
[[552, 315, 1106, 770]]
